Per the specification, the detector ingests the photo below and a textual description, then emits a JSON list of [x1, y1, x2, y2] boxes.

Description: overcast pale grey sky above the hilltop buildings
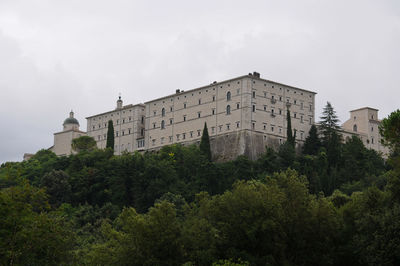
[[0, 0, 400, 163]]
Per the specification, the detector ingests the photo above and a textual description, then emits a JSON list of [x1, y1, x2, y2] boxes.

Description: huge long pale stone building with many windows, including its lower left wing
[[87, 72, 316, 160]]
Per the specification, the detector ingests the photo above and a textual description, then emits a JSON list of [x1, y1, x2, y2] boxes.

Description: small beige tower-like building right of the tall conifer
[[342, 107, 389, 156]]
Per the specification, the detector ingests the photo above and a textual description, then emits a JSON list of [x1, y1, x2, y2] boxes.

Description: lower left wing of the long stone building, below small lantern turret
[[86, 96, 145, 155]]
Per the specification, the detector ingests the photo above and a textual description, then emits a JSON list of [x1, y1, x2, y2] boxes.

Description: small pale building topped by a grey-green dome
[[49, 111, 86, 157]]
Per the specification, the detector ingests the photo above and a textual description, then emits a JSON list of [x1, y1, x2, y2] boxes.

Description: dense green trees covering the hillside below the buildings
[[0, 104, 400, 266]]
